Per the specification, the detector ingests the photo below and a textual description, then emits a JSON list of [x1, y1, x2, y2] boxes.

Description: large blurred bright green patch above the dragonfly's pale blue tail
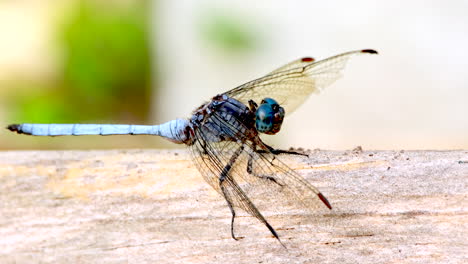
[[6, 1, 152, 123]]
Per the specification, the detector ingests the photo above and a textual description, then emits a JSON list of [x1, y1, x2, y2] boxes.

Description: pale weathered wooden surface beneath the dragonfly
[[0, 150, 468, 263]]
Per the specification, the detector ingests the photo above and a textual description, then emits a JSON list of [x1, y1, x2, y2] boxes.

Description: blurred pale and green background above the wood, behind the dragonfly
[[0, 0, 468, 149]]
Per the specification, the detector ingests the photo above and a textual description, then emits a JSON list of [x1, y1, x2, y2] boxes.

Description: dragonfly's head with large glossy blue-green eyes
[[255, 98, 284, 135]]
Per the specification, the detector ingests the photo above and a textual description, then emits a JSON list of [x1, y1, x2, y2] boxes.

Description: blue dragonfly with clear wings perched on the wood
[[7, 49, 377, 244]]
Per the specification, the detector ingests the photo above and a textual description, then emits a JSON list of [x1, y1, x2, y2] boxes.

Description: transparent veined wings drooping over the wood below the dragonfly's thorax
[[191, 136, 329, 212]]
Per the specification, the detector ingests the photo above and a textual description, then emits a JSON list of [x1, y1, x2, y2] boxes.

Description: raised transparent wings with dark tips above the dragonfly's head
[[225, 49, 377, 114]]
